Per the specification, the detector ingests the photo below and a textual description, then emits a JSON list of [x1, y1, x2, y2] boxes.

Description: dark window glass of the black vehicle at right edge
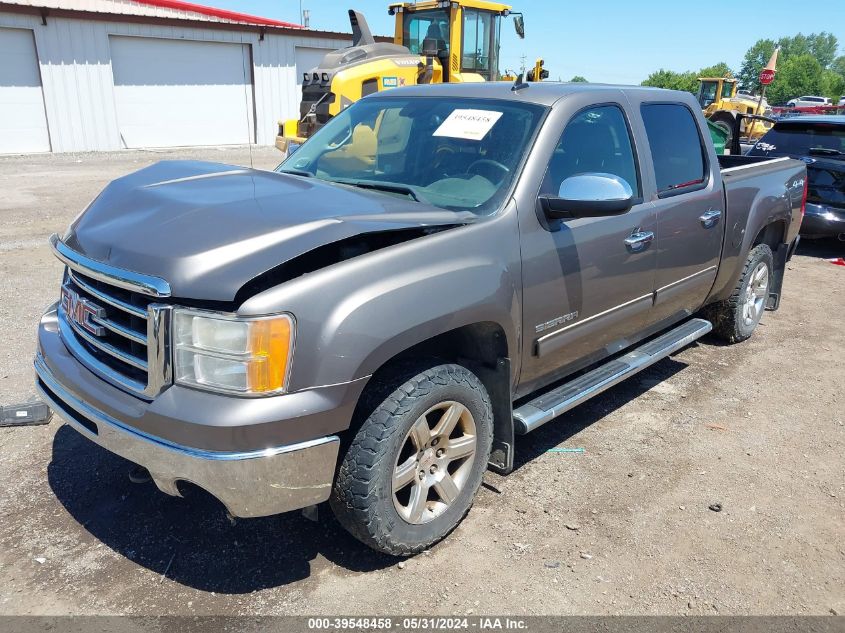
[[749, 122, 845, 157]]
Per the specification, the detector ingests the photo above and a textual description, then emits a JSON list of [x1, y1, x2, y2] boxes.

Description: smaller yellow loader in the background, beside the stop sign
[[698, 77, 772, 145]]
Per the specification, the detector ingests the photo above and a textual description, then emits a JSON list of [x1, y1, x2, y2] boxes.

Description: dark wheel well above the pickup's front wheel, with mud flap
[[341, 322, 513, 473]]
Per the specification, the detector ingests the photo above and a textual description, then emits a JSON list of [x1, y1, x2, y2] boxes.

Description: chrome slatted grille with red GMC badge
[[51, 237, 172, 398]]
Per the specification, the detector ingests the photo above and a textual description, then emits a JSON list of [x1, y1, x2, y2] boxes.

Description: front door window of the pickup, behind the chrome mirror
[[540, 105, 640, 198]]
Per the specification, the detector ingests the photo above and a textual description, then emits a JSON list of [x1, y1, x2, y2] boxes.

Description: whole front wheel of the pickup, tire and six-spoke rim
[[331, 365, 493, 556]]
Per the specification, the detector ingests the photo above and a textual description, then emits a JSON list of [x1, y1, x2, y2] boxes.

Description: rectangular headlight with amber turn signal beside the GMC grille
[[173, 308, 294, 395]]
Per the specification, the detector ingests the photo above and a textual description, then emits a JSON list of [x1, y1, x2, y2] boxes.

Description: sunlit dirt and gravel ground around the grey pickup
[[0, 149, 845, 615]]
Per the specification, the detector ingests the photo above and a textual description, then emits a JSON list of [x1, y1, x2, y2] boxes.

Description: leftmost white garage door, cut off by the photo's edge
[[0, 28, 50, 154]]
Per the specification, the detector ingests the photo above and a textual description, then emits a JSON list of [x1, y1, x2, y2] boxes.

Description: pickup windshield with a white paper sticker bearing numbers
[[277, 97, 545, 214]]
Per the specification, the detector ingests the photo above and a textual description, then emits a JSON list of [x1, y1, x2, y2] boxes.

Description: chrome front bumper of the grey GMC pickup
[[35, 310, 364, 517]]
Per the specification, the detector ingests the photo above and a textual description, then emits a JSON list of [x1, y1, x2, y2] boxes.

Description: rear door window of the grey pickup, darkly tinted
[[641, 103, 706, 194]]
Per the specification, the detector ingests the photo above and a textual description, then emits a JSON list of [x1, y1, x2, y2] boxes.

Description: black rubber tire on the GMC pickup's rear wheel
[[703, 244, 774, 343]]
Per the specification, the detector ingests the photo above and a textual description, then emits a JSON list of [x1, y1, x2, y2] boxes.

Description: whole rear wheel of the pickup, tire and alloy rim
[[704, 244, 774, 343]]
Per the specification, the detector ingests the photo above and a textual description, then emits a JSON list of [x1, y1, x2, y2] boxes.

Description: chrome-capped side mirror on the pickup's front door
[[540, 173, 634, 220]]
